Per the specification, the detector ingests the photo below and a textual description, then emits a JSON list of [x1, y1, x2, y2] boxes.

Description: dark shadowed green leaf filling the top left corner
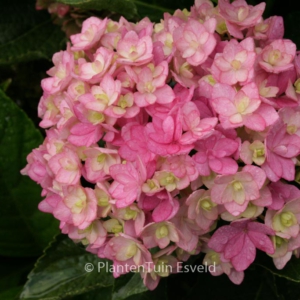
[[0, 0, 66, 65]]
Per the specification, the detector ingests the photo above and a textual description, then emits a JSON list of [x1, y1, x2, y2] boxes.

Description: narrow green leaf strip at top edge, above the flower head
[[57, 0, 137, 19]]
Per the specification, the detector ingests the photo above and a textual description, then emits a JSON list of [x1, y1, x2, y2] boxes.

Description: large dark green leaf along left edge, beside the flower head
[[0, 90, 58, 256]]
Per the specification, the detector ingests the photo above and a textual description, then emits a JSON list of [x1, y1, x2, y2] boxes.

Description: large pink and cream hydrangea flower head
[[22, 0, 300, 289]]
